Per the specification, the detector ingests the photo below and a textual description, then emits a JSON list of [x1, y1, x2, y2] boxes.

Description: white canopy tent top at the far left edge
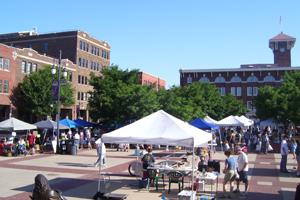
[[0, 117, 36, 131]]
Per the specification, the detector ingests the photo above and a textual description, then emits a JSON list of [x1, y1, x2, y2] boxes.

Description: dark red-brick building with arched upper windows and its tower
[[180, 33, 300, 115]]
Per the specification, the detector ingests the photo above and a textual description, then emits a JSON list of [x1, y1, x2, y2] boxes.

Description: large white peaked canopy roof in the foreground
[[102, 110, 212, 147]]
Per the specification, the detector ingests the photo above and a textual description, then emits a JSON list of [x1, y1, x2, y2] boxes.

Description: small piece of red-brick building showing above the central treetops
[[138, 72, 166, 91]]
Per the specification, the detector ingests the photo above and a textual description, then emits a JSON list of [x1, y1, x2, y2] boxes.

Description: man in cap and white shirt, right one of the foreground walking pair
[[235, 147, 248, 193]]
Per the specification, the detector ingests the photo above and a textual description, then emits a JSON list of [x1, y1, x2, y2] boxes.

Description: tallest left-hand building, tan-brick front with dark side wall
[[0, 30, 110, 119]]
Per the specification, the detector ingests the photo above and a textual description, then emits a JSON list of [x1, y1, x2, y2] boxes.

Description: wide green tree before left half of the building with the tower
[[159, 82, 246, 121]]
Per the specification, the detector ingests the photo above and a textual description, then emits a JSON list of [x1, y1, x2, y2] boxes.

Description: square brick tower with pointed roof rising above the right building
[[269, 32, 296, 67]]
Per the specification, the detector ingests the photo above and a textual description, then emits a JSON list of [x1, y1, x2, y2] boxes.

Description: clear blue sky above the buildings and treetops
[[0, 0, 300, 87]]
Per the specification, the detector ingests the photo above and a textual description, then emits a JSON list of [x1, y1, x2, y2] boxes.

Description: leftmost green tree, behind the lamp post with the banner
[[10, 66, 74, 122]]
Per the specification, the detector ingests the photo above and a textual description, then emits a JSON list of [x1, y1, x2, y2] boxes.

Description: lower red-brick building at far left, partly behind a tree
[[0, 44, 77, 120]]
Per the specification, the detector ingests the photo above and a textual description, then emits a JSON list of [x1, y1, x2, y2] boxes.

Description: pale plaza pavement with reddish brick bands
[[0, 149, 300, 200]]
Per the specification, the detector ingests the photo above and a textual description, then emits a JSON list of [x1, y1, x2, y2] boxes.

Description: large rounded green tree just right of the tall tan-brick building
[[89, 66, 159, 124]]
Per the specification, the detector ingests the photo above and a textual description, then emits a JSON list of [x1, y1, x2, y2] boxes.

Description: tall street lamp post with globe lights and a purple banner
[[51, 50, 67, 153]]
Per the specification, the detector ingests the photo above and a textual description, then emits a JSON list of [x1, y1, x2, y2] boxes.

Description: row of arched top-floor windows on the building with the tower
[[187, 73, 275, 83]]
